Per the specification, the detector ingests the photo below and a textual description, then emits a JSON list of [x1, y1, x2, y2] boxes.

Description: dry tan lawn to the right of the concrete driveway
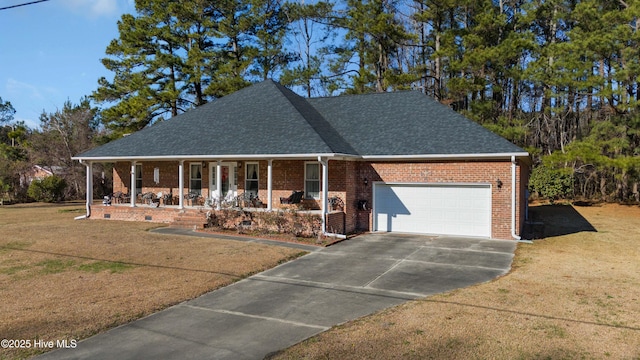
[[273, 205, 640, 360]]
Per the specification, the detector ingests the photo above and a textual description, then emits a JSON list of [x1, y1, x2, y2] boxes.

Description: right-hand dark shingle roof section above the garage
[[308, 91, 524, 156]]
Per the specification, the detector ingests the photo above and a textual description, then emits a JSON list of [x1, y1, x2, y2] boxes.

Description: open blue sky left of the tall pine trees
[[0, 0, 135, 128]]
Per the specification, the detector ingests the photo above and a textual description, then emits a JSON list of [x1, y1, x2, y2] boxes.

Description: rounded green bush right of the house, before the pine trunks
[[529, 165, 573, 201]]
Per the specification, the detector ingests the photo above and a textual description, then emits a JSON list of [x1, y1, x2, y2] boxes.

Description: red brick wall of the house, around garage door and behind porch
[[113, 160, 529, 239]]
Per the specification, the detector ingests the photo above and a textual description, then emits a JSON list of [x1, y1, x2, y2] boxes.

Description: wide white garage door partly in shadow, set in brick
[[373, 184, 491, 237]]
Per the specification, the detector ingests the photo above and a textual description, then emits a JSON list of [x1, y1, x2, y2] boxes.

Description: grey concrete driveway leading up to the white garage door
[[40, 233, 516, 360]]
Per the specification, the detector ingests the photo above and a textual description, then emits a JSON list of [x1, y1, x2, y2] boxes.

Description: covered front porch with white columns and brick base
[[83, 156, 348, 235]]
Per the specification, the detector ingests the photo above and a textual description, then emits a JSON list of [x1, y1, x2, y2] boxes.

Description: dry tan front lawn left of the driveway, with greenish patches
[[0, 204, 304, 359]]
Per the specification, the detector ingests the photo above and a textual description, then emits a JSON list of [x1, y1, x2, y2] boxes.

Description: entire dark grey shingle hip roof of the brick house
[[76, 80, 524, 160]]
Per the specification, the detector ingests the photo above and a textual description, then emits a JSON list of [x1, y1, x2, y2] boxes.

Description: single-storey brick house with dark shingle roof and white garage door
[[74, 80, 530, 239]]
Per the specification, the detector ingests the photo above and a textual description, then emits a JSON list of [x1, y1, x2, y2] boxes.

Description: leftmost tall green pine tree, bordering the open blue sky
[[93, 5, 186, 136]]
